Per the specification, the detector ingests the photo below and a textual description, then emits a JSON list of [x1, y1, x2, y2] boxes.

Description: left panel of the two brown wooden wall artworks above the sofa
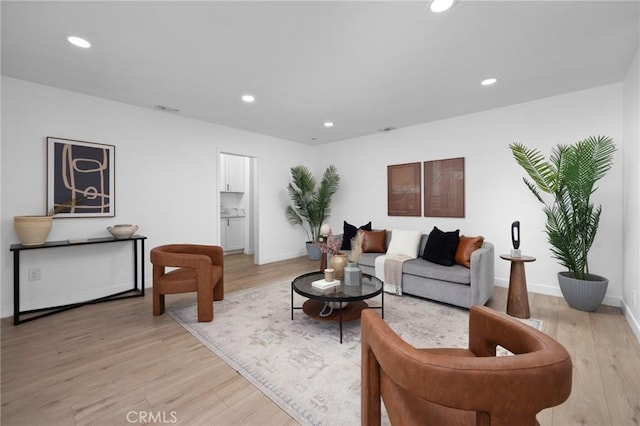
[[387, 162, 422, 216]]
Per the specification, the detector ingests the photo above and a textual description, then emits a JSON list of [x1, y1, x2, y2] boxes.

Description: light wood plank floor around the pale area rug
[[1, 255, 640, 426]]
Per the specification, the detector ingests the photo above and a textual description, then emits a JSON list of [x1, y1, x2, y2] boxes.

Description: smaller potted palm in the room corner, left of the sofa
[[285, 165, 340, 260]]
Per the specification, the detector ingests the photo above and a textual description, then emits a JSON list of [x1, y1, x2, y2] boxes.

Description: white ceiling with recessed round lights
[[2, 0, 640, 144]]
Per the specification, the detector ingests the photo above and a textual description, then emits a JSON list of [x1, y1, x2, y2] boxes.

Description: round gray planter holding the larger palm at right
[[558, 272, 609, 312]]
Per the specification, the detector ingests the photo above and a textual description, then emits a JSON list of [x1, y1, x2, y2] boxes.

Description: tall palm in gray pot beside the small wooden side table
[[509, 136, 616, 311]]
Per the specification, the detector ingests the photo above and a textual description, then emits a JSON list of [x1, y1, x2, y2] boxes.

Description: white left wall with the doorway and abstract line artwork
[[0, 77, 312, 316]]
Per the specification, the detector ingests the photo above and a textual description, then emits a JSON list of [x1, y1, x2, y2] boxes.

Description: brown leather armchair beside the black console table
[[151, 244, 224, 322]]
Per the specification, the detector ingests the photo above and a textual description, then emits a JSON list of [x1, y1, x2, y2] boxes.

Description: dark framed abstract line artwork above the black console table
[[47, 137, 116, 217]]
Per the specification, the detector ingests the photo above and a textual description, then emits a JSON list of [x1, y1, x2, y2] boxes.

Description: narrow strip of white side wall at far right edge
[[622, 51, 640, 339]]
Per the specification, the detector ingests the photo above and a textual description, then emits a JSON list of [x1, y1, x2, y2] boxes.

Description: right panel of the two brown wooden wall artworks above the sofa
[[424, 157, 464, 217]]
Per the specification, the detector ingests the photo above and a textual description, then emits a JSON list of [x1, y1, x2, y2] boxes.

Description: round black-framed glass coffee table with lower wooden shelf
[[291, 271, 384, 343]]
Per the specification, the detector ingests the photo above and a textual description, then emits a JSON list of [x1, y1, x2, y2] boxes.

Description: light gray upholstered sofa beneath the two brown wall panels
[[340, 231, 494, 309]]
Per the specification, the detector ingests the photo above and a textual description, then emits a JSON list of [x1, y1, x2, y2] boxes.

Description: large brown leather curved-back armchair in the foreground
[[361, 305, 572, 426]]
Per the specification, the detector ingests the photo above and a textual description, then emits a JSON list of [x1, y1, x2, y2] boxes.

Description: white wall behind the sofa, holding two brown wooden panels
[[320, 84, 624, 306]]
